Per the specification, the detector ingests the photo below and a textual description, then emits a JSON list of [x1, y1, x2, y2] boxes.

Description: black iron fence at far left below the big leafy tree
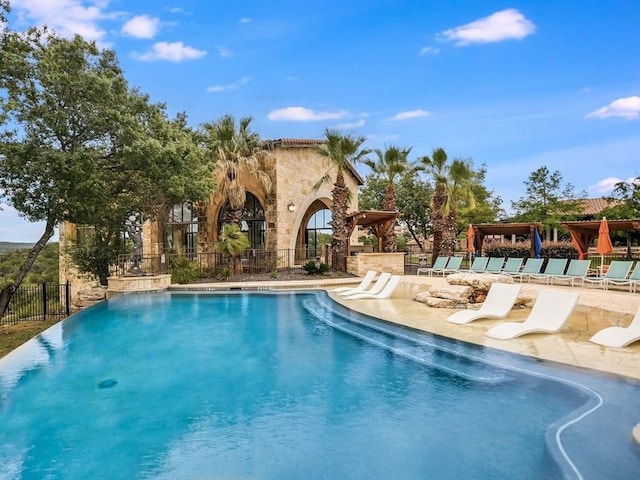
[[0, 282, 71, 325]]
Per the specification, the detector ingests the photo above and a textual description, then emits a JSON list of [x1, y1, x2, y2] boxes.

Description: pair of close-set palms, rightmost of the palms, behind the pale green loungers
[[420, 148, 475, 260]]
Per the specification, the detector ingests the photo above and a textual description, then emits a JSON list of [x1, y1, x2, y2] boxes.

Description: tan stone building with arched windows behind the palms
[[60, 139, 362, 300]]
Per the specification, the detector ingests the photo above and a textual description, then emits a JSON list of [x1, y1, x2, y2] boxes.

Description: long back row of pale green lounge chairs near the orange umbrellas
[[418, 256, 640, 292]]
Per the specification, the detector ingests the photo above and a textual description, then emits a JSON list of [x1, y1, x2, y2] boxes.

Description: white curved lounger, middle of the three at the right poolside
[[485, 290, 580, 340]]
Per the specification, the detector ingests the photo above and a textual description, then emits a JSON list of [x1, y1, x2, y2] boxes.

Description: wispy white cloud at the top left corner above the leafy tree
[[11, 0, 110, 41]]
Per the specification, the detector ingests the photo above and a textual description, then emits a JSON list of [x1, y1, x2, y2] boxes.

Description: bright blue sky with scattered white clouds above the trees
[[0, 0, 640, 241]]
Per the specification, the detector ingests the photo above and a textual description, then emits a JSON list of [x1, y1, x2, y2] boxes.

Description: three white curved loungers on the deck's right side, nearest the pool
[[447, 283, 640, 348]]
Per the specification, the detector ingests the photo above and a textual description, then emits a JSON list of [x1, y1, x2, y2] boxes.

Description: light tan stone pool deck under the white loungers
[[171, 275, 640, 380]]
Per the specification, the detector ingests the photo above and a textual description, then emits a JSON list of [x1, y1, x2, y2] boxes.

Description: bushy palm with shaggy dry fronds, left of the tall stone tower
[[202, 115, 271, 225]]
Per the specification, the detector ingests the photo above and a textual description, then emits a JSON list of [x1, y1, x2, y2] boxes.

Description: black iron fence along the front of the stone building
[[110, 248, 345, 277]]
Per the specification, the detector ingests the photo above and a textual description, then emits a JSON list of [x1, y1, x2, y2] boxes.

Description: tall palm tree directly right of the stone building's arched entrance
[[314, 129, 370, 270]]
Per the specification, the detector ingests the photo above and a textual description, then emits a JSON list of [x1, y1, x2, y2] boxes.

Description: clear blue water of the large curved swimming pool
[[0, 292, 640, 480]]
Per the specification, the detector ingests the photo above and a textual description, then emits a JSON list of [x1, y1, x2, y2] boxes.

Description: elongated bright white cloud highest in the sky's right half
[[441, 8, 536, 47]]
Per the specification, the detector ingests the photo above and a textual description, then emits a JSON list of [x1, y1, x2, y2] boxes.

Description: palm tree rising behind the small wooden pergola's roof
[[364, 145, 412, 252]]
